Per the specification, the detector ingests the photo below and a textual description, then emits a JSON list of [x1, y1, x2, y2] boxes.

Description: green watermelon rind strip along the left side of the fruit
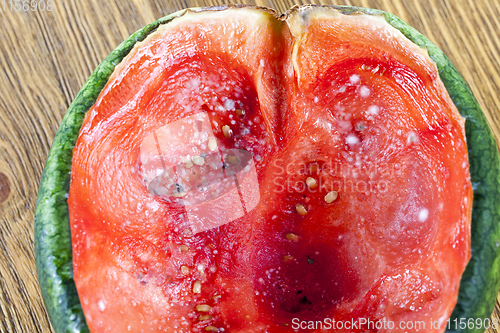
[[35, 10, 185, 333]]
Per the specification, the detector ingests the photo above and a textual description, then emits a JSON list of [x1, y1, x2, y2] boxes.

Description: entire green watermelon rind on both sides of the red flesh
[[35, 6, 500, 333]]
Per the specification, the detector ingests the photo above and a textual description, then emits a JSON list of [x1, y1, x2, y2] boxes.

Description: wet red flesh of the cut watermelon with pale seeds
[[68, 8, 472, 333]]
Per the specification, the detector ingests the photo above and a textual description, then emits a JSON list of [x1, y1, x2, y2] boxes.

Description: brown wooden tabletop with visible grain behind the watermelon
[[0, 0, 500, 333]]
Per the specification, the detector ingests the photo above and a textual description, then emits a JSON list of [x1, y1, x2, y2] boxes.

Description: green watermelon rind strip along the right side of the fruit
[[383, 8, 500, 333]]
